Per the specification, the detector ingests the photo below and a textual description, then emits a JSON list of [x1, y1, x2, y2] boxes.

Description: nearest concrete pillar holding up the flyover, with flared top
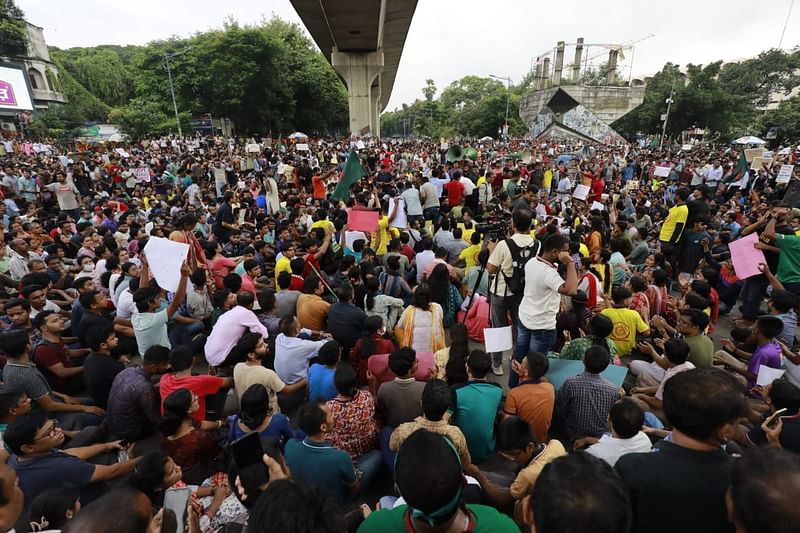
[[331, 49, 383, 135]]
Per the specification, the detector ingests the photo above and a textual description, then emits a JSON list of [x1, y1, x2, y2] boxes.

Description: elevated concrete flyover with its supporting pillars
[[291, 0, 417, 136]]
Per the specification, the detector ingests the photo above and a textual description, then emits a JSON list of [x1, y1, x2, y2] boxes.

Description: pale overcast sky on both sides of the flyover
[[17, 0, 800, 110]]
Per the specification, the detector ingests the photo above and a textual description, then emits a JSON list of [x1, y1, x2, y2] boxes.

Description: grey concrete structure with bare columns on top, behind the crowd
[[519, 37, 644, 144]]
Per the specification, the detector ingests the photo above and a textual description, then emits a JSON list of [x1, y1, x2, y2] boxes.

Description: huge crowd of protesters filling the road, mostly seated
[[0, 131, 800, 533]]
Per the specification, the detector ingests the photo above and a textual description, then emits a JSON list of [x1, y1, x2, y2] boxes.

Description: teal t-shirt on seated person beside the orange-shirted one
[[450, 381, 503, 464]]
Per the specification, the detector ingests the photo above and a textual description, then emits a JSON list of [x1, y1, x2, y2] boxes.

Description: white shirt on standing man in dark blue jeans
[[519, 257, 564, 330]]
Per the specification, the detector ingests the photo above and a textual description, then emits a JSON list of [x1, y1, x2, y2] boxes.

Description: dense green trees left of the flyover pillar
[[46, 18, 347, 136]]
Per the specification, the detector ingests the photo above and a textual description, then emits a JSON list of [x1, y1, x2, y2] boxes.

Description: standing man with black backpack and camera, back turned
[[486, 208, 539, 387]]
